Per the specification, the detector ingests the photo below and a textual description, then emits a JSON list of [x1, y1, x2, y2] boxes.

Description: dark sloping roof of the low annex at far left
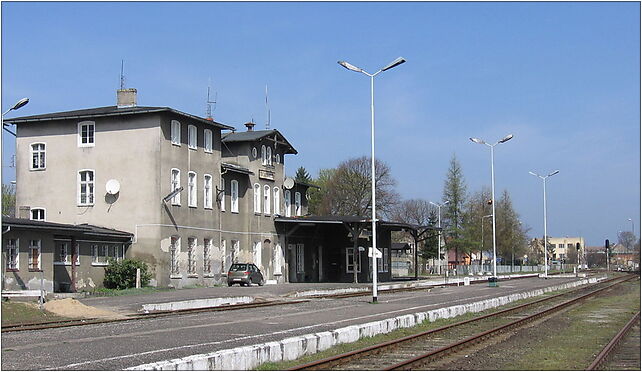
[[2, 216, 134, 240]]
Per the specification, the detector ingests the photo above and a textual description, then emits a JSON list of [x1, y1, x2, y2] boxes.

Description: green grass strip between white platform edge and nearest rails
[[256, 291, 565, 371]]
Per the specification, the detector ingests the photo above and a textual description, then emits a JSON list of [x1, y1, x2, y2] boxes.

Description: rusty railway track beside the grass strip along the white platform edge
[[290, 276, 634, 370]]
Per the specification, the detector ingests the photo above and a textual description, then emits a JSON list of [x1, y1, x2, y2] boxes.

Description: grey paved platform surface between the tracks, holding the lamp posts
[[1, 278, 574, 370]]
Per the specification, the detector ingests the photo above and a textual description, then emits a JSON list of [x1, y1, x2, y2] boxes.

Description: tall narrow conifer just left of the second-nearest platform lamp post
[[442, 154, 472, 261]]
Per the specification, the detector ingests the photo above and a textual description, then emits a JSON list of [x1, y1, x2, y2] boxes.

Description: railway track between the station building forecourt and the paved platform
[[2, 299, 309, 333]]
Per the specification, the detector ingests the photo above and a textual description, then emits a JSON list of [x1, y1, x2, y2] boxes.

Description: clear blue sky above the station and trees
[[1, 2, 640, 246]]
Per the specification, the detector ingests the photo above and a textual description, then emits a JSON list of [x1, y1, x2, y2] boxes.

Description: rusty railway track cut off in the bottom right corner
[[586, 311, 640, 371]]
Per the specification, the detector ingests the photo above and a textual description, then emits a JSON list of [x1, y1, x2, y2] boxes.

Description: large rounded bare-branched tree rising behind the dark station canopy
[[320, 156, 399, 218]]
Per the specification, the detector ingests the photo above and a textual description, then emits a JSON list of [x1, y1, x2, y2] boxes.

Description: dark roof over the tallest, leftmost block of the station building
[[4, 106, 234, 130]]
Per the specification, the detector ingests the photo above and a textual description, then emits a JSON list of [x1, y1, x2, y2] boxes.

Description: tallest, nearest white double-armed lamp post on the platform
[[337, 57, 406, 302]]
